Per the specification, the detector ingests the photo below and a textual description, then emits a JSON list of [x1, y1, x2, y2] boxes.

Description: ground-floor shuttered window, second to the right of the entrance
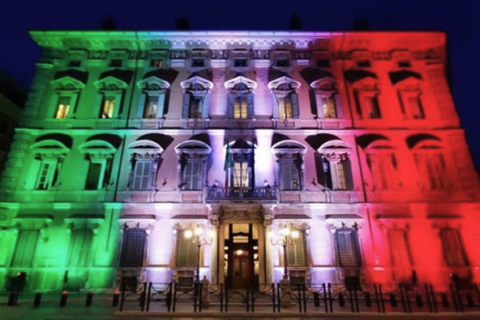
[[334, 228, 362, 267]]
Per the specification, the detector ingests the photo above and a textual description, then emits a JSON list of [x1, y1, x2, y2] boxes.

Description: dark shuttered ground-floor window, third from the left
[[120, 228, 147, 268]]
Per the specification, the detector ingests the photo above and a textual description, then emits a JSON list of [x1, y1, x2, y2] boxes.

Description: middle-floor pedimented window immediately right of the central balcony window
[[272, 140, 307, 190]]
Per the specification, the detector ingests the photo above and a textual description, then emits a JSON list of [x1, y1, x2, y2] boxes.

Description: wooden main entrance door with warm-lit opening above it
[[225, 223, 258, 289]]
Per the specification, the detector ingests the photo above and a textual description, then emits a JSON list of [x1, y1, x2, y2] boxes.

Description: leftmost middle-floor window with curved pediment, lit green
[[30, 140, 70, 190]]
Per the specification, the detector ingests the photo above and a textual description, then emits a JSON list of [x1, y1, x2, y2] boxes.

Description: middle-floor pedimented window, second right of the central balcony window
[[318, 140, 354, 190]]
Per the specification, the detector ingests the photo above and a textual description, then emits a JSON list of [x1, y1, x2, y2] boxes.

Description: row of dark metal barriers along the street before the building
[[115, 278, 480, 313]]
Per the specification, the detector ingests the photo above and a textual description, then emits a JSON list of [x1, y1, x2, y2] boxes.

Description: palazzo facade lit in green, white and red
[[0, 31, 480, 291]]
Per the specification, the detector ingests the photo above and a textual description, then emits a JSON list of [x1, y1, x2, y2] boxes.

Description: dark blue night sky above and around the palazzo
[[0, 0, 480, 168]]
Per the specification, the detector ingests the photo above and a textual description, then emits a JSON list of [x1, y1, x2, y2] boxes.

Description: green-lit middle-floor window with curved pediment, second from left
[[79, 140, 116, 190]]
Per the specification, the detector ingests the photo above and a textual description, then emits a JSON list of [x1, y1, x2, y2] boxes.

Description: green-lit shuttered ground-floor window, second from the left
[[67, 230, 93, 268]]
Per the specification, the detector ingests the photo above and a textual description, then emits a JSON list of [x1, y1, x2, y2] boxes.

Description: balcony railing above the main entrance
[[207, 186, 277, 200]]
